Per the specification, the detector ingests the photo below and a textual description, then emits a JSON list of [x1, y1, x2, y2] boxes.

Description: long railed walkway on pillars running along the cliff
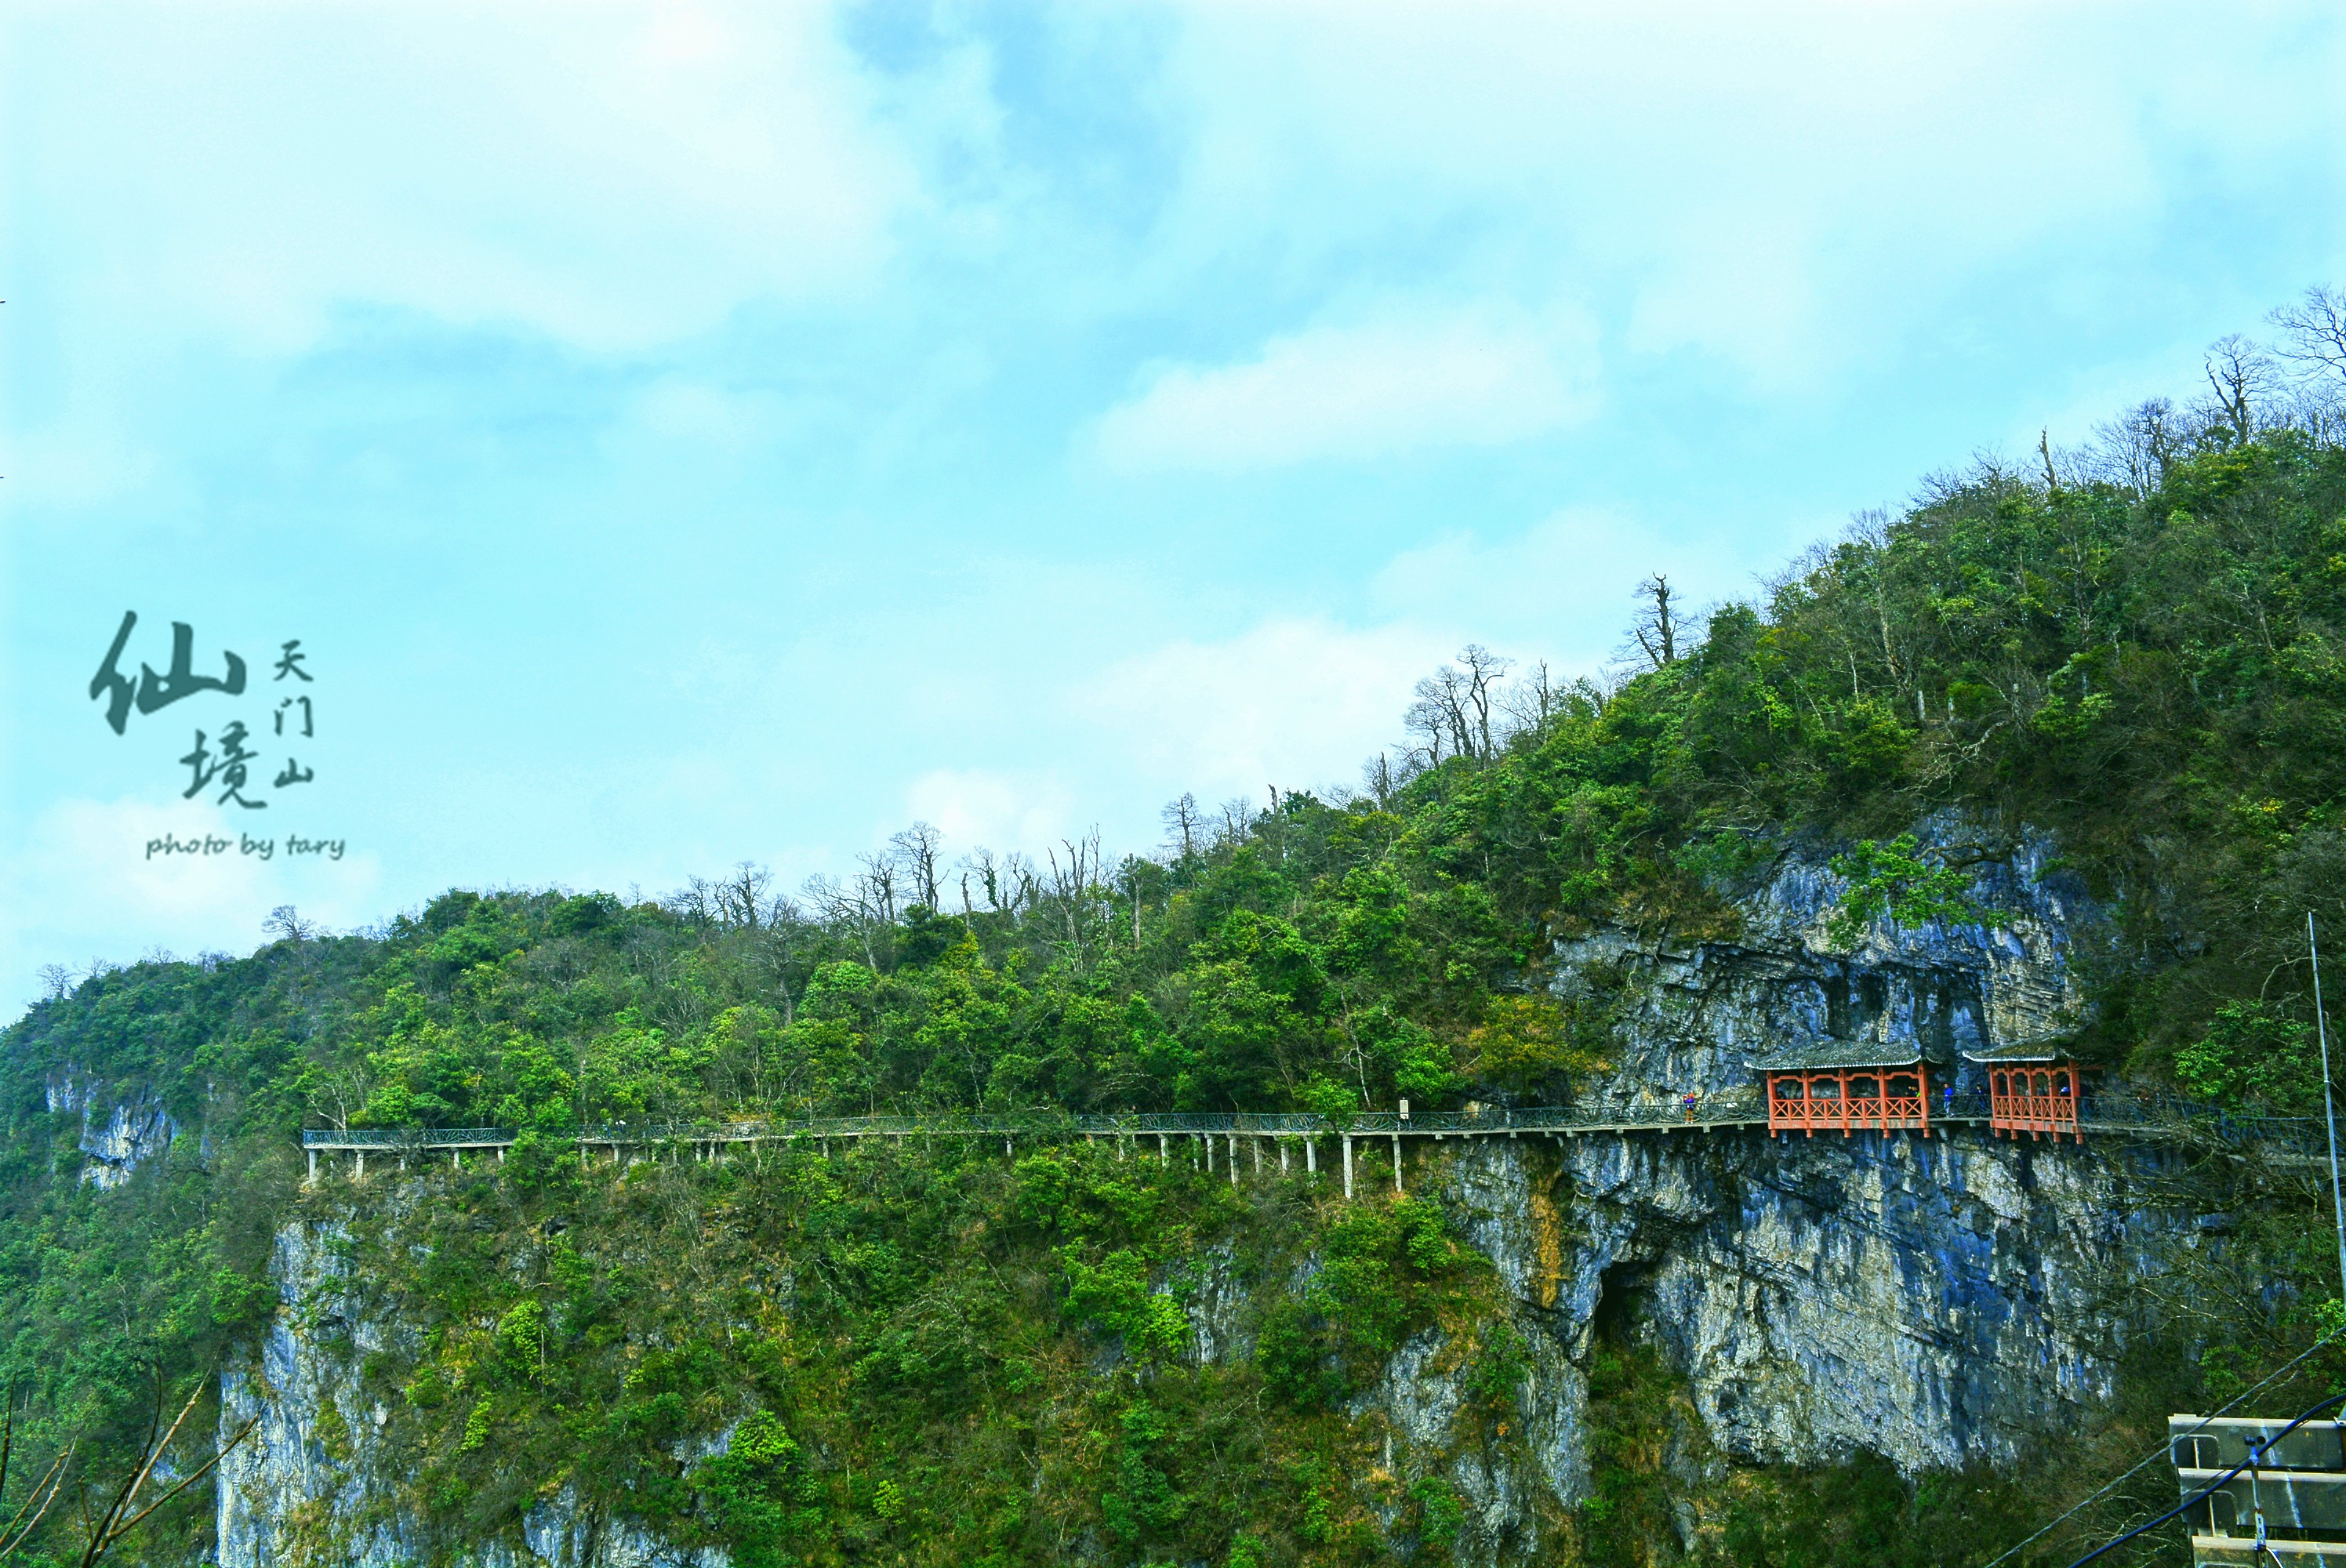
[[300, 1091, 2322, 1197]]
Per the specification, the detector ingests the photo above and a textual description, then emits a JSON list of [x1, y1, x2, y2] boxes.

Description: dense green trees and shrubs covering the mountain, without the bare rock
[[13, 291, 2346, 1566]]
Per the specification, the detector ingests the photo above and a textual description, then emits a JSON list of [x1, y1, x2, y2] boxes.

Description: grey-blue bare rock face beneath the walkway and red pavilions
[[1363, 1112, 2168, 1559]]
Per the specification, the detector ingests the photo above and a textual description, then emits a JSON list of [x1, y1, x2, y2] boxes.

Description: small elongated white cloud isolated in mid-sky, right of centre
[[1093, 310, 1596, 472]]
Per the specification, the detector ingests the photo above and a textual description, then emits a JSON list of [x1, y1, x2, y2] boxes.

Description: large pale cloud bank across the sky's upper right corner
[[1152, 0, 2346, 392]]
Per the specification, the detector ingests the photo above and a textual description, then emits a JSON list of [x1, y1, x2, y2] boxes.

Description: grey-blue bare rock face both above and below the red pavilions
[[1323, 824, 2148, 1561]]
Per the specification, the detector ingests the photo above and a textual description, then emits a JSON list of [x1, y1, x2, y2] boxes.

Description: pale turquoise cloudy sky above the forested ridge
[[0, 5, 2346, 1009]]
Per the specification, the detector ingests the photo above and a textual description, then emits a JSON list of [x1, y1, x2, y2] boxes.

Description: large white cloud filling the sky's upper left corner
[[9, 5, 915, 352]]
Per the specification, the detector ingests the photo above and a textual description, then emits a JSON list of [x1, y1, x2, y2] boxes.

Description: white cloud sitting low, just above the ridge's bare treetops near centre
[[1074, 619, 1452, 803]]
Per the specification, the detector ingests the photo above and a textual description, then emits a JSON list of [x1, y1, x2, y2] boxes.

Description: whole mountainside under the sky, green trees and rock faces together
[[0, 412, 2346, 1563]]
